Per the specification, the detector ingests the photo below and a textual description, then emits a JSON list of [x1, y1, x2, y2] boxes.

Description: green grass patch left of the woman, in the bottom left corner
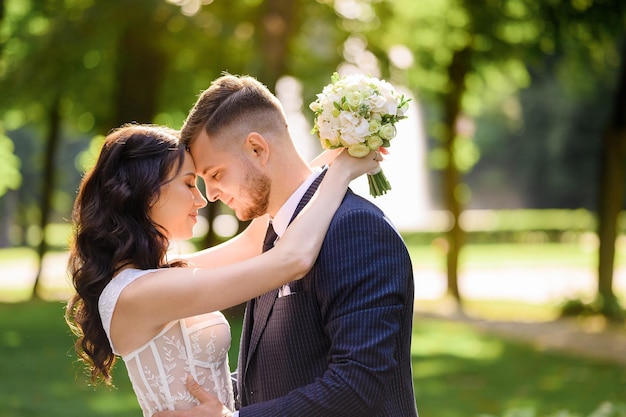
[[0, 301, 141, 417]]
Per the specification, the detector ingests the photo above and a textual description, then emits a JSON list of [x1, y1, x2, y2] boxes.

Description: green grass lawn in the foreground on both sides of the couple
[[0, 301, 626, 417]]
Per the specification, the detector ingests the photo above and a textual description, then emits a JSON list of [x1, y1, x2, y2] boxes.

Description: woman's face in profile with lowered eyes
[[149, 152, 207, 239]]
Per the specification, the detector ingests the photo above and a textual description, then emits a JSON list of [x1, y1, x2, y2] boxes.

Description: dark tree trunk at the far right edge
[[596, 42, 626, 320]]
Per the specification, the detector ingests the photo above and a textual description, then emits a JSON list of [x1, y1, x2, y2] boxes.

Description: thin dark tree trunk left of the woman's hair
[[32, 96, 61, 298]]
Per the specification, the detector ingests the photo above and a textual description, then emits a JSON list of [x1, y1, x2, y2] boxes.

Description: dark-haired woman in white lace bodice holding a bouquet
[[65, 125, 379, 416]]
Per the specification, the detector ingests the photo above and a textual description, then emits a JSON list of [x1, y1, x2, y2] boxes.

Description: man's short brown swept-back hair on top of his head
[[181, 74, 287, 146]]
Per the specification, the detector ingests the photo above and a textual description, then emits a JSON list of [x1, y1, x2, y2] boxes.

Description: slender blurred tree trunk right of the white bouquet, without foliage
[[443, 47, 471, 307]]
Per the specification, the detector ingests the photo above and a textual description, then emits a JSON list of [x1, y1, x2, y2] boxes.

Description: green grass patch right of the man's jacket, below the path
[[412, 318, 626, 417]]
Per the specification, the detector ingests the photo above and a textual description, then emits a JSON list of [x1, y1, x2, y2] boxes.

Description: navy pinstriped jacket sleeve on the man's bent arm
[[240, 209, 413, 417]]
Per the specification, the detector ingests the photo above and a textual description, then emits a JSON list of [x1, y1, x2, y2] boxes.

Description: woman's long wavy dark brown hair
[[65, 124, 190, 384]]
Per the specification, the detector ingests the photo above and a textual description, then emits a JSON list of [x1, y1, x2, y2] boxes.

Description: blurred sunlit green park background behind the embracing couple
[[0, 0, 626, 417]]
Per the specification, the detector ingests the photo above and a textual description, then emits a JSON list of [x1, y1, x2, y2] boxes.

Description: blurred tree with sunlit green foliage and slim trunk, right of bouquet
[[384, 0, 541, 307]]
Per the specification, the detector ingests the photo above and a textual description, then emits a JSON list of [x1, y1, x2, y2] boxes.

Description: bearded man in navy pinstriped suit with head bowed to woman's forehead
[[161, 75, 417, 417]]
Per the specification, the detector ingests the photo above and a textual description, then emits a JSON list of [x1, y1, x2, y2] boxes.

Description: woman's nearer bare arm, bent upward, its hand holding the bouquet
[[116, 152, 378, 328]]
